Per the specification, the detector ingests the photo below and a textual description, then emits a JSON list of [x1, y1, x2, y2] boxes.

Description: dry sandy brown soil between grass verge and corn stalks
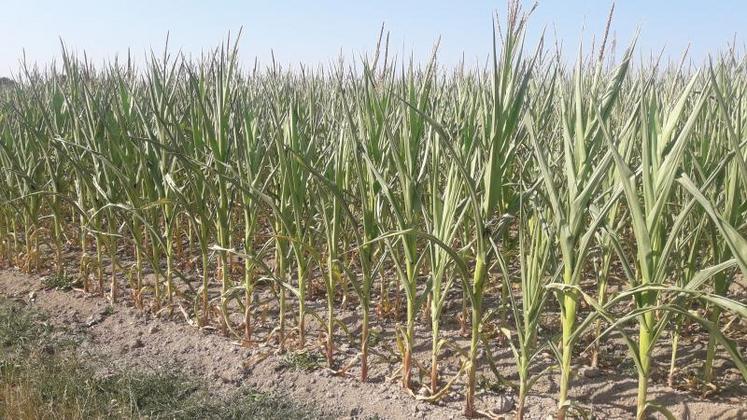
[[0, 270, 747, 419]]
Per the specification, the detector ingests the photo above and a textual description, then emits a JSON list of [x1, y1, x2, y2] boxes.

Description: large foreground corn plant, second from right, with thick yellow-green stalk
[[526, 37, 632, 418]]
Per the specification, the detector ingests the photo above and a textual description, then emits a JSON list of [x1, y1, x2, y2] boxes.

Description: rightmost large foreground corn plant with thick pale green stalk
[[605, 75, 741, 419]]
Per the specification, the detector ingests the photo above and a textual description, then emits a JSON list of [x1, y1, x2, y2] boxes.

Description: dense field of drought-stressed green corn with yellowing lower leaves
[[0, 5, 747, 419]]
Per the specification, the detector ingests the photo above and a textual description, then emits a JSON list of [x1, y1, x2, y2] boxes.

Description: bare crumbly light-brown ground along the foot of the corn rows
[[0, 270, 747, 419]]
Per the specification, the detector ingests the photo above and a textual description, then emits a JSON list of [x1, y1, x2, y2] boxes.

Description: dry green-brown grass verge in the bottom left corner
[[0, 300, 328, 420]]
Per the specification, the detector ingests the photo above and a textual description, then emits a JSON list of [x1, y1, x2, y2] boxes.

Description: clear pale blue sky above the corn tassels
[[0, 0, 747, 75]]
